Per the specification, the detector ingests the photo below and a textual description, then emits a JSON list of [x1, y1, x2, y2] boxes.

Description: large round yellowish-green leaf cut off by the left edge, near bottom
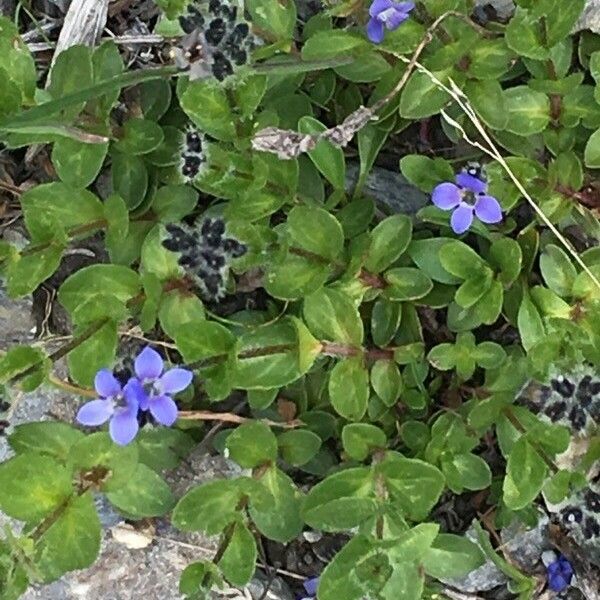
[[0, 452, 73, 522]]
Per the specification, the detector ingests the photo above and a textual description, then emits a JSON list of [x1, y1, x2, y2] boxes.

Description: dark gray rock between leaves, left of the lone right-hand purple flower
[[346, 162, 429, 215]]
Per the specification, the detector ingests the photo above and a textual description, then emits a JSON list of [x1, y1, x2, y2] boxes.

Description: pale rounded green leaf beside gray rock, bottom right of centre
[[423, 533, 485, 579]]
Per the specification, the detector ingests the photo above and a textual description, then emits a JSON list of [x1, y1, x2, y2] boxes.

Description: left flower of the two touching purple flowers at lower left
[[76, 369, 139, 446]]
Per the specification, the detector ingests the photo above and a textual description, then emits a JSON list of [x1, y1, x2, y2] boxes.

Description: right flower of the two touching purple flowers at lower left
[[133, 346, 193, 426]]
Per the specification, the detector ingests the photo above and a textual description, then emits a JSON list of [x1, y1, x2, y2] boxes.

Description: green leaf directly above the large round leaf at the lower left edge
[[8, 421, 85, 461]]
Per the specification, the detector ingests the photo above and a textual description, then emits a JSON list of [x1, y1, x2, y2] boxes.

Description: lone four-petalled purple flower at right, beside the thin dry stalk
[[431, 171, 502, 234]]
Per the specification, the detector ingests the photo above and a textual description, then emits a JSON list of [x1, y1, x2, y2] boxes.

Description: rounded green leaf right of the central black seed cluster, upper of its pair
[[287, 206, 344, 261]]
